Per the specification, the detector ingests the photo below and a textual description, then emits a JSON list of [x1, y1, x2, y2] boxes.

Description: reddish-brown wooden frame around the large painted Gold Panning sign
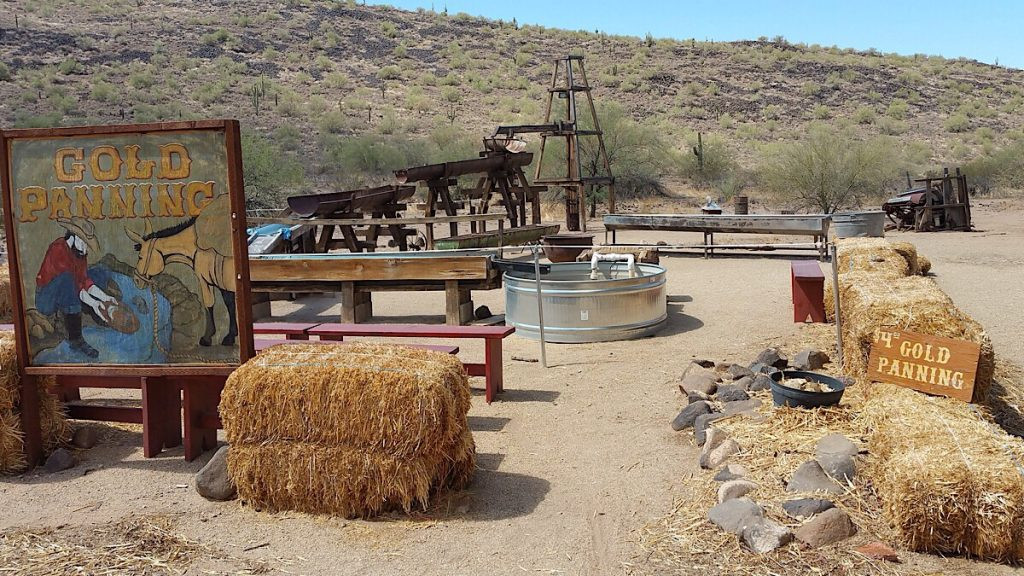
[[0, 120, 255, 377]]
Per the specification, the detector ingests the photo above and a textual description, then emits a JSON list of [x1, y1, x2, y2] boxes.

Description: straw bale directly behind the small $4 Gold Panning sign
[[840, 275, 995, 402]]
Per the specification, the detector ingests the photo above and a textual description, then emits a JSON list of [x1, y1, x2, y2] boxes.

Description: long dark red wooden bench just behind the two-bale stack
[[301, 324, 515, 404]]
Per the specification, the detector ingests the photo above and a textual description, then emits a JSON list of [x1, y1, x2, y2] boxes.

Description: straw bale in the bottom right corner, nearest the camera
[[860, 384, 1024, 562]]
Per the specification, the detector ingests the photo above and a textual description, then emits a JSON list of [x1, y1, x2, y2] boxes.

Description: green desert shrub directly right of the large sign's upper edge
[[242, 132, 305, 209]]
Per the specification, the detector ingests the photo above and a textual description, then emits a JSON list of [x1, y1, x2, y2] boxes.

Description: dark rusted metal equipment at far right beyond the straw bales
[[882, 168, 971, 232]]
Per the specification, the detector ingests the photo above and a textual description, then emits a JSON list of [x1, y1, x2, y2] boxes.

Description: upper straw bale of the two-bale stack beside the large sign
[[220, 344, 470, 456]]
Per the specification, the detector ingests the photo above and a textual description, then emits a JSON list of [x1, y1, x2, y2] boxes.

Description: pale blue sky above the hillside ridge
[[369, 0, 1024, 68]]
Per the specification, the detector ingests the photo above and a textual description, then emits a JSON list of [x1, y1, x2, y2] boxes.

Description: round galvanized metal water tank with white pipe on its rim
[[505, 262, 668, 343]]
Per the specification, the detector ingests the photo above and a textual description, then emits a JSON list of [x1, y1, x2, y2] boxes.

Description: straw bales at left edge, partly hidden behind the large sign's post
[[0, 332, 72, 474]]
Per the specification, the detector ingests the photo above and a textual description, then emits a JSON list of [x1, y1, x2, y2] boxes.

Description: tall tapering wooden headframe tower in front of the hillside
[[534, 55, 615, 232]]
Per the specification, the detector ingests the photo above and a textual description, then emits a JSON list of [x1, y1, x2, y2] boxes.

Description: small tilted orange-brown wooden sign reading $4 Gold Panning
[[867, 328, 981, 402]]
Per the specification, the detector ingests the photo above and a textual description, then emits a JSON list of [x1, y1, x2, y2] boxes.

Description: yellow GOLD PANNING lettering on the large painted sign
[[14, 142, 217, 222]]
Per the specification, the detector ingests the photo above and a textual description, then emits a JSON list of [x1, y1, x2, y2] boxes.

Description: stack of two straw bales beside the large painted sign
[[220, 344, 475, 518]]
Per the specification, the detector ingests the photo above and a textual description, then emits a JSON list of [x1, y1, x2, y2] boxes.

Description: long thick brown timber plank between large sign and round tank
[[249, 256, 490, 282]]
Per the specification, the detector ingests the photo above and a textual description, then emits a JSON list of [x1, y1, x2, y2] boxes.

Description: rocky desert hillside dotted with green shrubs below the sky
[[0, 0, 1024, 203]]
